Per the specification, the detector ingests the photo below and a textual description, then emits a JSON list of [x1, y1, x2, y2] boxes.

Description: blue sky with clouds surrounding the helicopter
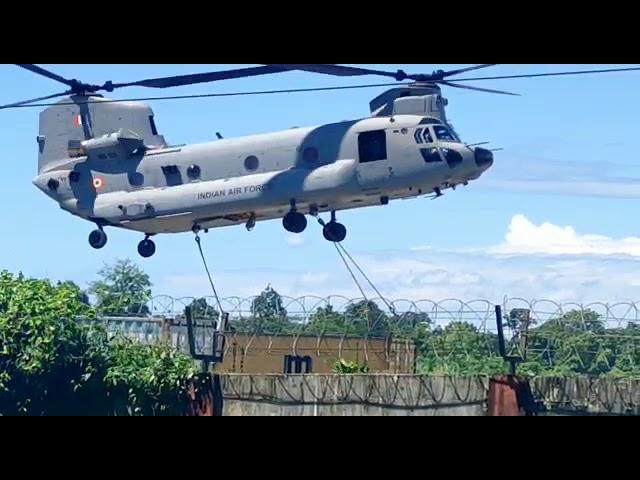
[[0, 65, 640, 301]]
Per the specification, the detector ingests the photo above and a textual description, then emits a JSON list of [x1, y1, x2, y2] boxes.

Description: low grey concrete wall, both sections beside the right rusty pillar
[[220, 374, 640, 416]]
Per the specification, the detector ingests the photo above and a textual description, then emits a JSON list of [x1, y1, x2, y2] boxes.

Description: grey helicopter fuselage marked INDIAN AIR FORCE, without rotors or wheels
[[34, 115, 493, 235]]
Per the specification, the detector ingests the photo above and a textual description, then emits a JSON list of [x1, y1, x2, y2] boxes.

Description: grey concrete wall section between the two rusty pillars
[[221, 375, 488, 416]]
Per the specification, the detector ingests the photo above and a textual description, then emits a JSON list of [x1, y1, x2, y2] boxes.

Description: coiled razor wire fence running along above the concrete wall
[[75, 295, 640, 375]]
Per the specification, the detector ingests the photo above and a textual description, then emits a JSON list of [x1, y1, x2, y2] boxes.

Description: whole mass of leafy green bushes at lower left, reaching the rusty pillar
[[0, 272, 195, 415]]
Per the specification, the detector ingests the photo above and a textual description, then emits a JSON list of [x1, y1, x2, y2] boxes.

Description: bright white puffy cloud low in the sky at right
[[488, 215, 640, 257]]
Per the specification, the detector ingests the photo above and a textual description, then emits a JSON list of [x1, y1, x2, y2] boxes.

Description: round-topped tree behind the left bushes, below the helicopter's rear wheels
[[89, 260, 152, 315]]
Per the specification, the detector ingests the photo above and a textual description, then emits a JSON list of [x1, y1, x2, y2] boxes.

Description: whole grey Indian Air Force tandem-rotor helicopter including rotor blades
[[0, 64, 640, 258]]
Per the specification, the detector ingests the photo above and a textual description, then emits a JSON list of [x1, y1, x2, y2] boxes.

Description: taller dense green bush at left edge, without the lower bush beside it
[[0, 272, 103, 415]]
